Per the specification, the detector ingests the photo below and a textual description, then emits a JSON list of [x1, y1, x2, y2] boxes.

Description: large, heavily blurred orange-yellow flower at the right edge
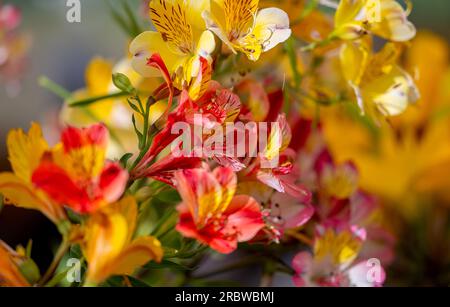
[[322, 33, 450, 216]]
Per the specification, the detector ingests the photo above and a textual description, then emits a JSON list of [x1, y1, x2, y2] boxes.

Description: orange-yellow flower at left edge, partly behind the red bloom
[[0, 123, 66, 224]]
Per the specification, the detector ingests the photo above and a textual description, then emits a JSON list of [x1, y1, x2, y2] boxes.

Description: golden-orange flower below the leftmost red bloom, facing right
[[83, 197, 163, 285]]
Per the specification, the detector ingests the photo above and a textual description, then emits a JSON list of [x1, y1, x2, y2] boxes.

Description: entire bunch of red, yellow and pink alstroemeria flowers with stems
[[0, 0, 449, 286]]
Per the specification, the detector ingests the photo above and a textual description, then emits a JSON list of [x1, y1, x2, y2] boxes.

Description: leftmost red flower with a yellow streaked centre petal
[[32, 124, 128, 213]]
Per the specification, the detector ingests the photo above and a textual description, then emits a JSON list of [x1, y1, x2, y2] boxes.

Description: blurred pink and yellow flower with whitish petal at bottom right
[[292, 227, 385, 287]]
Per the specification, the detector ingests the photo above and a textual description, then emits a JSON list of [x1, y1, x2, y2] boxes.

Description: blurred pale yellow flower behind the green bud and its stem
[[60, 57, 166, 158]]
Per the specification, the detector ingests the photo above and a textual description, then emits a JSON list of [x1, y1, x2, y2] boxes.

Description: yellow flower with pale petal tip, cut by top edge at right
[[332, 0, 416, 42]]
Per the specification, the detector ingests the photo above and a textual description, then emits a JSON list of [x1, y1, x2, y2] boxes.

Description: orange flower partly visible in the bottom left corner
[[0, 241, 30, 287]]
